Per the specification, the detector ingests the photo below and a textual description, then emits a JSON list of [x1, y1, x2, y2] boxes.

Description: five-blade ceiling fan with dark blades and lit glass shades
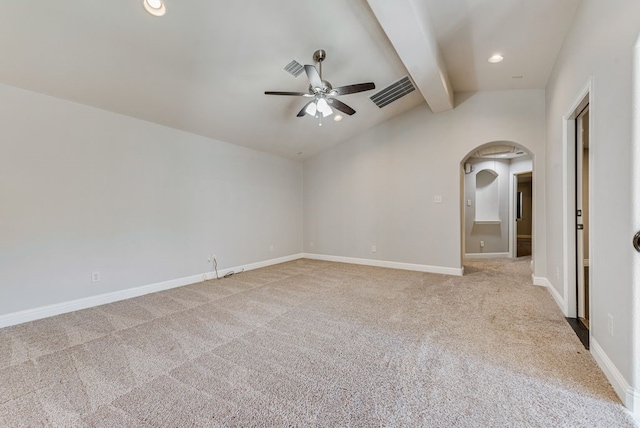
[[265, 49, 376, 126]]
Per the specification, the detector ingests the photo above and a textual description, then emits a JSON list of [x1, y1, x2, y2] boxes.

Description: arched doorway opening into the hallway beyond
[[460, 141, 535, 262]]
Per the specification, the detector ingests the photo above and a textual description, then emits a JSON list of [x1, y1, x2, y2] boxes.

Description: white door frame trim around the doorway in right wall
[[556, 78, 594, 318]]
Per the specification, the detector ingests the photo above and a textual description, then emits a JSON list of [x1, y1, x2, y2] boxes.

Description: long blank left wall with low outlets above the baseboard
[[0, 85, 302, 315]]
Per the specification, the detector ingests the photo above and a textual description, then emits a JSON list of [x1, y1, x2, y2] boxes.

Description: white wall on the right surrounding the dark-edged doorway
[[545, 0, 640, 413]]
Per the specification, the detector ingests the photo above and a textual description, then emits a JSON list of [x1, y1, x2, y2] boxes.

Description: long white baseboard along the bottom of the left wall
[[0, 254, 302, 328]]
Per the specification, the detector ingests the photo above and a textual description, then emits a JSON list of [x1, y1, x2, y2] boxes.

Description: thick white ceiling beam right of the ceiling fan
[[367, 0, 453, 113]]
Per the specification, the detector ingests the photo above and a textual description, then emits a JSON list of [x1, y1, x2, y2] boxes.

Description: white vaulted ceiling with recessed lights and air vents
[[0, 0, 580, 159]]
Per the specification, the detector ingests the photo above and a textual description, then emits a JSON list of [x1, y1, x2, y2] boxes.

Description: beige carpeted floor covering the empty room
[[0, 258, 634, 428]]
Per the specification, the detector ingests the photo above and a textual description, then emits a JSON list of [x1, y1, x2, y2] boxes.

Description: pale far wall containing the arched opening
[[304, 90, 546, 273]]
